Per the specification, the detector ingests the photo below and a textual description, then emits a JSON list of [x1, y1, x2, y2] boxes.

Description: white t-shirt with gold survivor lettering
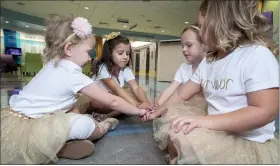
[[191, 45, 279, 143]]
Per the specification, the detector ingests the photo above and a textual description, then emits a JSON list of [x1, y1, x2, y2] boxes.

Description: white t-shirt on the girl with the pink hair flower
[[10, 59, 93, 118]]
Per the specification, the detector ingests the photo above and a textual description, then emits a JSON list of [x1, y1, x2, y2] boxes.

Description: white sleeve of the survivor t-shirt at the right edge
[[243, 46, 279, 93]]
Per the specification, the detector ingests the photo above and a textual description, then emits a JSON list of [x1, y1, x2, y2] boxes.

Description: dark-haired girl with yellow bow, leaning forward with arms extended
[[89, 32, 153, 121]]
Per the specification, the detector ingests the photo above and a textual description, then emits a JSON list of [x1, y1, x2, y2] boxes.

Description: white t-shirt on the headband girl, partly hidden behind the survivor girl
[[174, 63, 193, 84]]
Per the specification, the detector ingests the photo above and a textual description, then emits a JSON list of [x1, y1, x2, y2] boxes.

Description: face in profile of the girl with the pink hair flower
[[71, 36, 96, 67]]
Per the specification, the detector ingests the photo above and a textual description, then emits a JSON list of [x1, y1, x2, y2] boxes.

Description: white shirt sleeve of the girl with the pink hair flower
[[69, 70, 93, 93]]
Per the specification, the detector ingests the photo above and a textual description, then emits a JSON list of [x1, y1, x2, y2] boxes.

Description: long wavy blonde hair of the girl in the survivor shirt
[[199, 0, 273, 58]]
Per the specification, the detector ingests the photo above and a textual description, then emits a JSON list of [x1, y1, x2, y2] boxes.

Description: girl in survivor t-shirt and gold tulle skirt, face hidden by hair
[[147, 0, 279, 164]]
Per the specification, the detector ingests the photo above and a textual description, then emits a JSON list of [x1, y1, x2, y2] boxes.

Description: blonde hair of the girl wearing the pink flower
[[43, 15, 83, 65]]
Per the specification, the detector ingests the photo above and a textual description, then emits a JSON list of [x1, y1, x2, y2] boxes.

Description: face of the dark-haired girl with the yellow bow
[[112, 43, 131, 69]]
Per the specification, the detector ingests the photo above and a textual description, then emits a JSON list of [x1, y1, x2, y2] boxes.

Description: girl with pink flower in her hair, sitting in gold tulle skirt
[[1, 16, 149, 164]]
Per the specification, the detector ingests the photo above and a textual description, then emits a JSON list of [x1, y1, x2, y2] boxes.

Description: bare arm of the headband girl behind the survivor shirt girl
[[156, 80, 182, 106]]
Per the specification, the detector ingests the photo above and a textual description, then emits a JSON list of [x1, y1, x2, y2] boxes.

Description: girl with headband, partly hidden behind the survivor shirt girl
[[155, 25, 206, 106]]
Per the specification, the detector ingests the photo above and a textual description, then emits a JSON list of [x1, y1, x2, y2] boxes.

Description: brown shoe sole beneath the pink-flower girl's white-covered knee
[[57, 140, 94, 160]]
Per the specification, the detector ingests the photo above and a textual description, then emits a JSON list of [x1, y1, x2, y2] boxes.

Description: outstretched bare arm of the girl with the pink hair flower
[[80, 83, 147, 116]]
